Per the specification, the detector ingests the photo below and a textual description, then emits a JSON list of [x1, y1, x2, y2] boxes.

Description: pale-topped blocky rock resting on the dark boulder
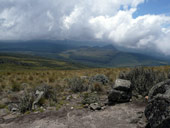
[[114, 79, 131, 91]]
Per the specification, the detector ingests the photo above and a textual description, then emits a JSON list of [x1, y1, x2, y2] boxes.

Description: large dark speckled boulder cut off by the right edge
[[145, 80, 170, 128]]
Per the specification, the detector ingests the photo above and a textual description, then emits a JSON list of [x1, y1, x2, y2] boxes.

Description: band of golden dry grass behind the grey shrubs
[[0, 66, 170, 91]]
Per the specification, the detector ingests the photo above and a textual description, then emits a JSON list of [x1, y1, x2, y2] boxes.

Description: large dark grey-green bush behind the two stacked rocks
[[119, 67, 167, 96]]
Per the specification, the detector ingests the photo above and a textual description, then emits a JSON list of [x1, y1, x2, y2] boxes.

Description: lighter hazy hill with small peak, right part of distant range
[[60, 46, 169, 67]]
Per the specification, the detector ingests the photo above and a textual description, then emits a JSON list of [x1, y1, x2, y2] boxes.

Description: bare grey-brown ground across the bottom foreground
[[0, 103, 144, 128]]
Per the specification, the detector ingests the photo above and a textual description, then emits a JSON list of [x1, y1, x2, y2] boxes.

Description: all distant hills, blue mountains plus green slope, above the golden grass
[[0, 41, 170, 69]]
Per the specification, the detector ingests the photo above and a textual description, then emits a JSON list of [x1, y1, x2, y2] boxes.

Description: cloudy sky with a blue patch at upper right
[[0, 0, 170, 55]]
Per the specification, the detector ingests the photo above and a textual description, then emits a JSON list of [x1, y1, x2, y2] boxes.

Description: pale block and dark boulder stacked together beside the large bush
[[108, 79, 132, 104]]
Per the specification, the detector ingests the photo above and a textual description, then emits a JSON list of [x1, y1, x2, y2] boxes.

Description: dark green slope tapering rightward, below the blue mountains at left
[[0, 53, 87, 70]]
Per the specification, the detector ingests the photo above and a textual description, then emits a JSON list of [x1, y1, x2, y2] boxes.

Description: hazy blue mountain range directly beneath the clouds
[[0, 40, 170, 67]]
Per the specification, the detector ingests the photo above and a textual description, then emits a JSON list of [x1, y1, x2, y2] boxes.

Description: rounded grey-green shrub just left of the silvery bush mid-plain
[[68, 77, 88, 93]]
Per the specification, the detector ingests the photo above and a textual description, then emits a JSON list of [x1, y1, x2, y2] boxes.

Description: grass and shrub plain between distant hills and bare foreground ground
[[0, 63, 170, 113]]
